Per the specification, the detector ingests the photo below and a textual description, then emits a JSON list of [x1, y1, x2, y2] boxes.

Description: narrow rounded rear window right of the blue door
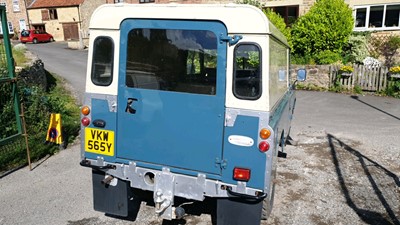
[[233, 44, 261, 100]]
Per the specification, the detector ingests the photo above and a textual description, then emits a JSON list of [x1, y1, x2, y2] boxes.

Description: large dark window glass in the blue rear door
[[125, 29, 218, 95]]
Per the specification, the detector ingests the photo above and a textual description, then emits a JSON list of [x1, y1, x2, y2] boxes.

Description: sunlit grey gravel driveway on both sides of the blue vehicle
[[0, 91, 400, 225]]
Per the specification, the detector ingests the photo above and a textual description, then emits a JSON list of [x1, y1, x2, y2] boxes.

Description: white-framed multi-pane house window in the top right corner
[[354, 4, 400, 31]]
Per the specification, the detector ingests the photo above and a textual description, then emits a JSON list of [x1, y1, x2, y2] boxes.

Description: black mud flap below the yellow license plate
[[92, 170, 132, 217]]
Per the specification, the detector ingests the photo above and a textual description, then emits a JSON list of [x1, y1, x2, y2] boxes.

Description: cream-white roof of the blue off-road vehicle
[[90, 3, 286, 43]]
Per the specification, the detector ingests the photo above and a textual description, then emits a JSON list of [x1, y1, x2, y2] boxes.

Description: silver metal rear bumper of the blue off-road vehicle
[[81, 158, 266, 201]]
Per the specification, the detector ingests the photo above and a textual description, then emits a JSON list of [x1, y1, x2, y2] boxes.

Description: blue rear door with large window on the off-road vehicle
[[117, 19, 227, 175]]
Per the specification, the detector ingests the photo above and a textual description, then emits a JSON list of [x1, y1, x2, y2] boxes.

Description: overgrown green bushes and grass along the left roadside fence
[[0, 62, 80, 171]]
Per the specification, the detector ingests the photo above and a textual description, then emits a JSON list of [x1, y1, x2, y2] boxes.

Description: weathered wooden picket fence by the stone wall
[[329, 65, 388, 92]]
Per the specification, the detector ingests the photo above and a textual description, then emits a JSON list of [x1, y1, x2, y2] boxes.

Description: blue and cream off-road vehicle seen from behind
[[81, 5, 304, 225]]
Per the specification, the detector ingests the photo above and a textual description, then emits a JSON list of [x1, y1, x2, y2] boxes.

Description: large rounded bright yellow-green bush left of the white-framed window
[[292, 0, 354, 61]]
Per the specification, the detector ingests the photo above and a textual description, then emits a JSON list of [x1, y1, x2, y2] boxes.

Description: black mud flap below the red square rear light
[[216, 198, 263, 225]]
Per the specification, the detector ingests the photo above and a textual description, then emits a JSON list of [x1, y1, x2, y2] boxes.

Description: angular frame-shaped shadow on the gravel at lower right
[[327, 134, 400, 225]]
